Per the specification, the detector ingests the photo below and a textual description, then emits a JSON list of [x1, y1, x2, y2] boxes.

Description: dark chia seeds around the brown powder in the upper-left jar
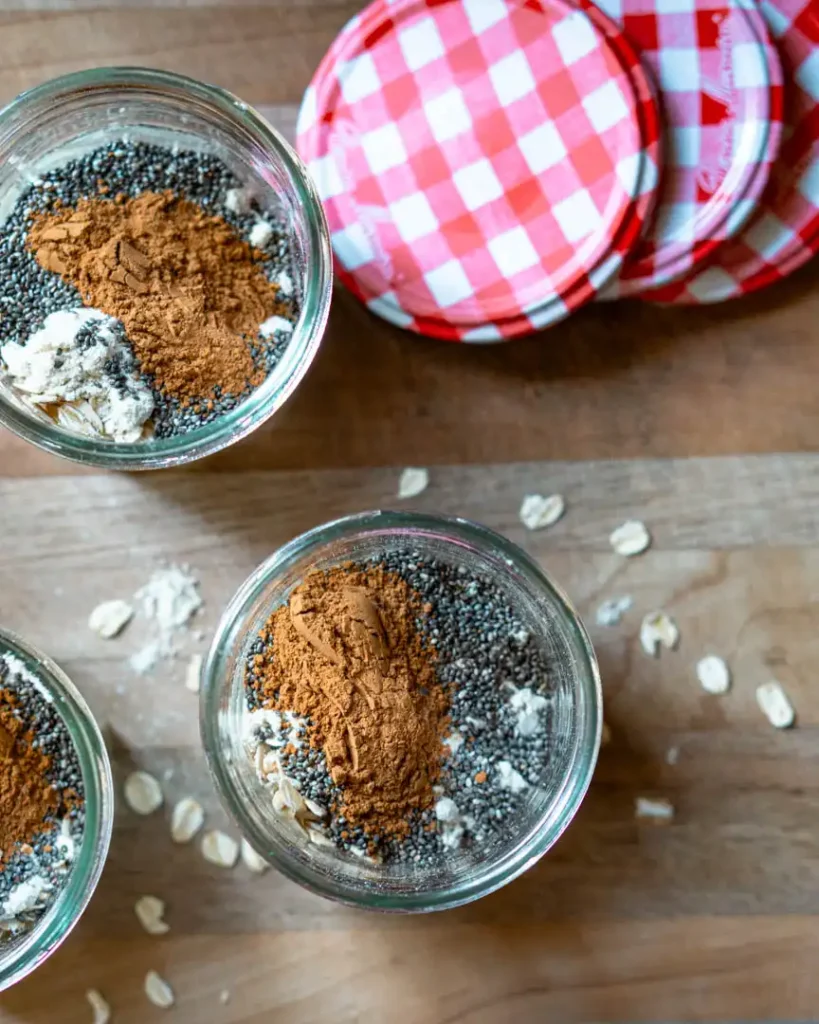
[[0, 139, 299, 437]]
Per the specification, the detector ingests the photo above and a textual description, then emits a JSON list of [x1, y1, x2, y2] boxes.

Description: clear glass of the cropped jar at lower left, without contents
[[0, 630, 114, 992]]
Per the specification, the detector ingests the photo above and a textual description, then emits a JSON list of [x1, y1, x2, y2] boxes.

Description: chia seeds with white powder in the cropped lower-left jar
[[0, 652, 85, 948]]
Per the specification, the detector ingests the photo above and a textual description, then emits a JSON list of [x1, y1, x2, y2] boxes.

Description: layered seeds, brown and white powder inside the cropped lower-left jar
[[0, 652, 85, 946]]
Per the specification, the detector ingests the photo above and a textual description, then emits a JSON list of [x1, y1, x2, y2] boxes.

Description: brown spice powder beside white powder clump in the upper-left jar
[[28, 191, 287, 404]]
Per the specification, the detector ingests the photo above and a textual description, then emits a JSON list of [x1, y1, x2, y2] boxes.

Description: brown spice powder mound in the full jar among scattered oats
[[256, 567, 449, 837]]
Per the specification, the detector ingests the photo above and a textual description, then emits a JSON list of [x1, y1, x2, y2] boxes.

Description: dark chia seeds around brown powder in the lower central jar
[[245, 550, 552, 865]]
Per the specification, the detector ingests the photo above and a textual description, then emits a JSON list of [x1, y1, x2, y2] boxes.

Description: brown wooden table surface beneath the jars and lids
[[0, 0, 819, 1024]]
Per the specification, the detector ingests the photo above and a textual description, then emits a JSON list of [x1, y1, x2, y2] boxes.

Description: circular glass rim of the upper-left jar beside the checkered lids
[[0, 66, 333, 470]]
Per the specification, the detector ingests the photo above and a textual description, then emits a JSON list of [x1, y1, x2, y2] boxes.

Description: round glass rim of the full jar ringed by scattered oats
[[200, 510, 603, 912]]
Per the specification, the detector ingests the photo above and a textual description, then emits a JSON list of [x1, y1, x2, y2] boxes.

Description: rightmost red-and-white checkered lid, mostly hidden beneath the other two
[[644, 0, 819, 303]]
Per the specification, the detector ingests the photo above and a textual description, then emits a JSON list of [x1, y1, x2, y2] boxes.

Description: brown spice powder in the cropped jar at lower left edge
[[0, 690, 59, 870]]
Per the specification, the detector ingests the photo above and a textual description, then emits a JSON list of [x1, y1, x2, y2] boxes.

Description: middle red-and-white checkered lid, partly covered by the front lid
[[598, 0, 783, 298]]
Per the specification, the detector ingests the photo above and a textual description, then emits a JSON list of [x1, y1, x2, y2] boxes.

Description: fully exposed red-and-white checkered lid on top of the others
[[297, 0, 659, 342]]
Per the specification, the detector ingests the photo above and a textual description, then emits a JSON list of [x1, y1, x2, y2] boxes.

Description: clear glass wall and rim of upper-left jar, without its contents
[[0, 68, 333, 470]]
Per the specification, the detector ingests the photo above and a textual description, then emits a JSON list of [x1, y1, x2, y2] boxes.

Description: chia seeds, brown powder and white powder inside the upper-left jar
[[0, 141, 298, 442]]
